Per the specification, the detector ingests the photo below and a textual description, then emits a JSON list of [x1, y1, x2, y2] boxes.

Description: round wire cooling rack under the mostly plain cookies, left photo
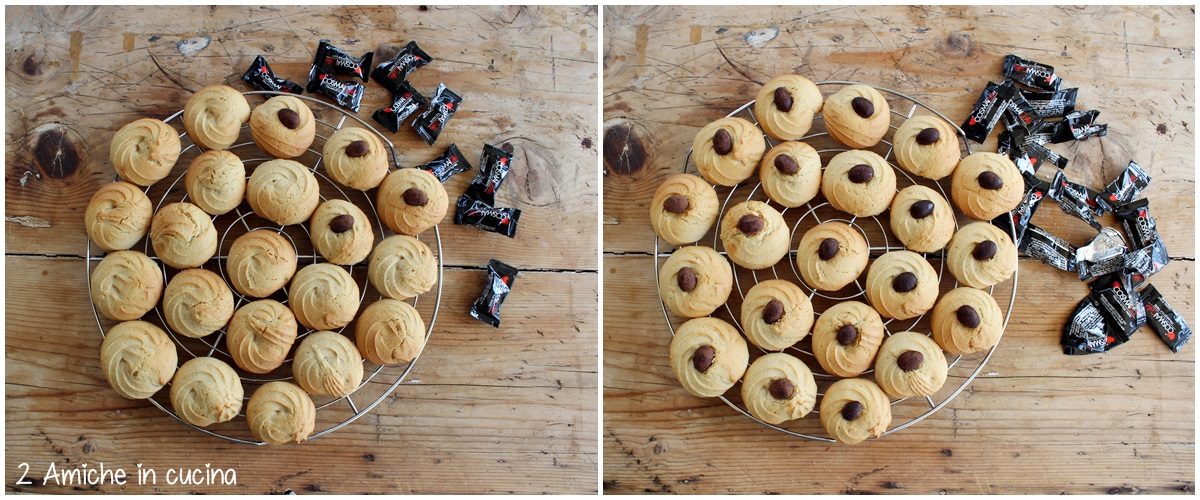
[[85, 91, 443, 445]]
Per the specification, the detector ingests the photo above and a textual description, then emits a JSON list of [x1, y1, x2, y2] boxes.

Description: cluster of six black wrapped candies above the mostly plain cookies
[[241, 40, 462, 145]]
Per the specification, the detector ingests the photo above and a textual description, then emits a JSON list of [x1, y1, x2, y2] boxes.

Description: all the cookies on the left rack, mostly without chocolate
[[85, 85, 449, 444]]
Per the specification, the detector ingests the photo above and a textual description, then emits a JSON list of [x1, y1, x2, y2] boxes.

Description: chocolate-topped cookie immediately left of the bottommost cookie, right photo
[[742, 353, 817, 424]]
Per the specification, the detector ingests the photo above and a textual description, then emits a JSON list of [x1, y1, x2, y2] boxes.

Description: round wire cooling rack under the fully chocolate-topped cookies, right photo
[[654, 82, 1018, 442]]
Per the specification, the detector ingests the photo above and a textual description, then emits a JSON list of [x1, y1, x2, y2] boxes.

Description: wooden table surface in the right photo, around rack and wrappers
[[602, 6, 1196, 494]]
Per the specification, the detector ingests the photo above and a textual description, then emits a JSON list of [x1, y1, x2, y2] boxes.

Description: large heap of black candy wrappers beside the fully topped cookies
[[962, 55, 1192, 355]]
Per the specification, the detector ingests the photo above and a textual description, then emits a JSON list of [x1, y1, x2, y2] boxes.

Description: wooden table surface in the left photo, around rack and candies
[[5, 6, 599, 494]]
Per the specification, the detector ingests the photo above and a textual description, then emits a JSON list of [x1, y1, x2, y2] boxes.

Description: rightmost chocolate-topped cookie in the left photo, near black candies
[[377, 168, 450, 236]]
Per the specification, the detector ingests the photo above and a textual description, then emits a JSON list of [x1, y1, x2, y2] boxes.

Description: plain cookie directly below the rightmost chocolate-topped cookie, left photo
[[367, 234, 438, 300]]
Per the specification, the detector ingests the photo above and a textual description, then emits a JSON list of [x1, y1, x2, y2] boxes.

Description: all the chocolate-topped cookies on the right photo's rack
[[650, 74, 1024, 444]]
